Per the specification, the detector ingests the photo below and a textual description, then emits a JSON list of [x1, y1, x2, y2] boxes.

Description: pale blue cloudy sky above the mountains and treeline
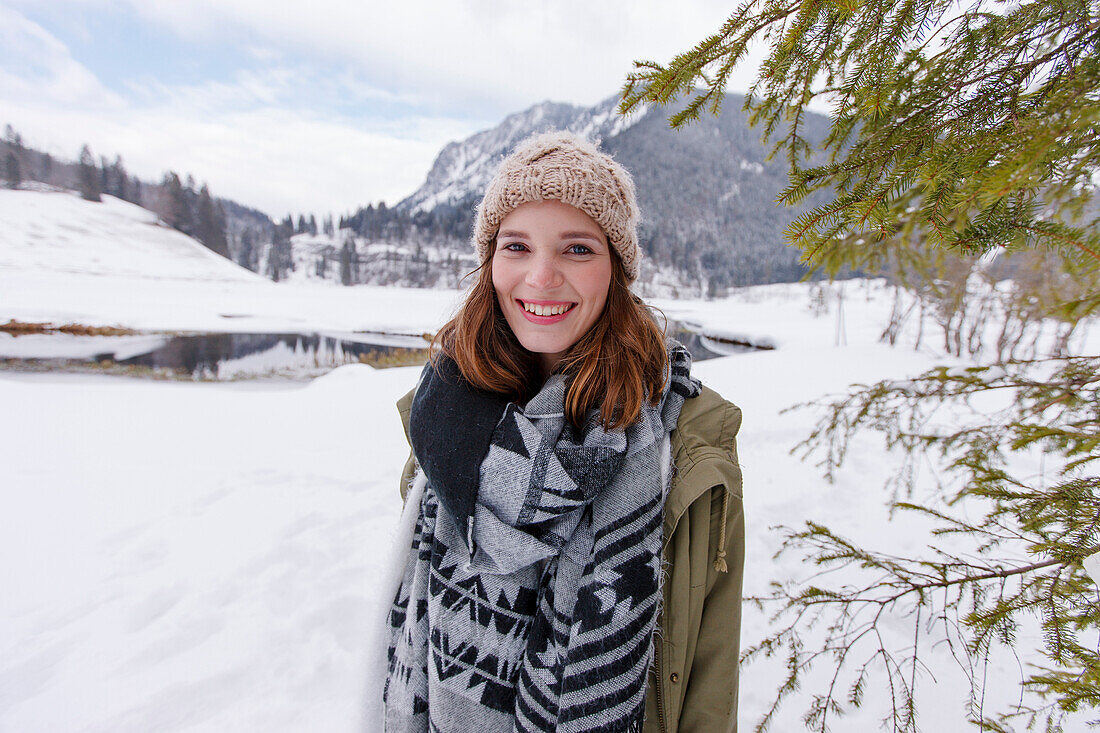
[[0, 0, 751, 218]]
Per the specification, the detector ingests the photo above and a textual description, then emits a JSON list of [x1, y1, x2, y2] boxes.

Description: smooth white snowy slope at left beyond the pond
[[0, 189, 459, 338]]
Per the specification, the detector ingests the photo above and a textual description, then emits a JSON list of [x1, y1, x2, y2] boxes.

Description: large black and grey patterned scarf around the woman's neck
[[384, 341, 700, 733]]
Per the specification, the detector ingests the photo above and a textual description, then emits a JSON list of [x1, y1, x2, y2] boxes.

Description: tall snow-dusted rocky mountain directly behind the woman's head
[[395, 88, 828, 294]]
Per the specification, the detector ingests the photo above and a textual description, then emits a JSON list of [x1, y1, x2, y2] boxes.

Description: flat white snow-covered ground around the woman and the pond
[[0, 192, 1096, 733]]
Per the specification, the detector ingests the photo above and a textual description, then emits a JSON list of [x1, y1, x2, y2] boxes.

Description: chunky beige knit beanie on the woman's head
[[473, 132, 638, 282]]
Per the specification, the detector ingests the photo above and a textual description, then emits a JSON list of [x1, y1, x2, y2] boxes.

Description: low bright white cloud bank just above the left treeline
[[4, 82, 473, 217]]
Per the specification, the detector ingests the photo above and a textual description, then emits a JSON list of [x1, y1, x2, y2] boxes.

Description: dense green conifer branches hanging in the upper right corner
[[620, 0, 1100, 263]]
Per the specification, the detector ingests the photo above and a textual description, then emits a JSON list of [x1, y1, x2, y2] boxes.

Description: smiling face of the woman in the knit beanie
[[492, 199, 612, 373]]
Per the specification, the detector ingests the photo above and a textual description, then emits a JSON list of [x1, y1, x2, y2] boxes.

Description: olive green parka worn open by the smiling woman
[[397, 386, 745, 733]]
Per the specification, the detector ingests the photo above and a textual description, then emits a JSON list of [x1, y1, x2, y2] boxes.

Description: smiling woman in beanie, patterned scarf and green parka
[[374, 133, 744, 733]]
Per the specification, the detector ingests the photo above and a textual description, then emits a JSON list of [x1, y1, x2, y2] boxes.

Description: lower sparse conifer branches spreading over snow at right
[[745, 357, 1100, 731]]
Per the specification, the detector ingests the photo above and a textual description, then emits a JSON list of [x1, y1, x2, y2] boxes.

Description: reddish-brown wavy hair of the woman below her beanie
[[431, 250, 668, 430]]
